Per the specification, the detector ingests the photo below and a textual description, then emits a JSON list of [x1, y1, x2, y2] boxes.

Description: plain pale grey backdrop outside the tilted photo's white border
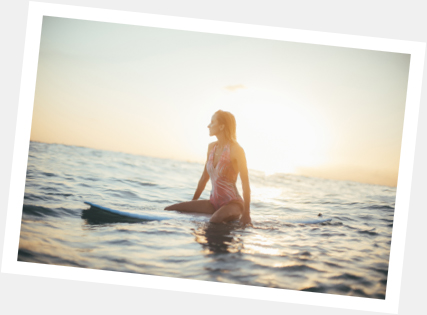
[[0, 0, 427, 315]]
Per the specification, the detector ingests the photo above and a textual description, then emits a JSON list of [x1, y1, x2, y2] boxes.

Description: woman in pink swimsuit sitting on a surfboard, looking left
[[165, 110, 251, 224]]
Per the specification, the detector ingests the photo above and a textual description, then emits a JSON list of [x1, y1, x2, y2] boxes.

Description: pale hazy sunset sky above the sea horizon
[[31, 17, 410, 186]]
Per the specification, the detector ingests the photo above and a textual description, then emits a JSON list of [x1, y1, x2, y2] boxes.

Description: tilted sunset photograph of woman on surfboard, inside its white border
[[17, 16, 411, 300]]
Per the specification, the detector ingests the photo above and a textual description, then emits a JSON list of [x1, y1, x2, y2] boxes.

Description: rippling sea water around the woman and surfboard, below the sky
[[18, 142, 396, 299]]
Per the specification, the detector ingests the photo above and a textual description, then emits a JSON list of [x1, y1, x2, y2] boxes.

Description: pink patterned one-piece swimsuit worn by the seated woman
[[206, 144, 244, 210]]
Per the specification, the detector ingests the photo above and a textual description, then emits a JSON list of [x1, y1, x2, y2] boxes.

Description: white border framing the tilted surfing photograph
[[1, 2, 426, 314]]
